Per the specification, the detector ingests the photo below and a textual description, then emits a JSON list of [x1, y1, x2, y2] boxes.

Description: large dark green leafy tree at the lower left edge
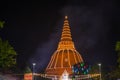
[[0, 38, 17, 71]]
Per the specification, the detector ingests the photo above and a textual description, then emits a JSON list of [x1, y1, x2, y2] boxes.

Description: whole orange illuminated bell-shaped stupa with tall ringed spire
[[46, 16, 83, 76]]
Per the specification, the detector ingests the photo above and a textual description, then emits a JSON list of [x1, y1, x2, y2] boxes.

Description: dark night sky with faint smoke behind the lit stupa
[[0, 0, 120, 71]]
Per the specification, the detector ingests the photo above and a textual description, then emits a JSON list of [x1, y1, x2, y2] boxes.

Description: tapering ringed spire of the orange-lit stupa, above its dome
[[58, 16, 75, 49]]
